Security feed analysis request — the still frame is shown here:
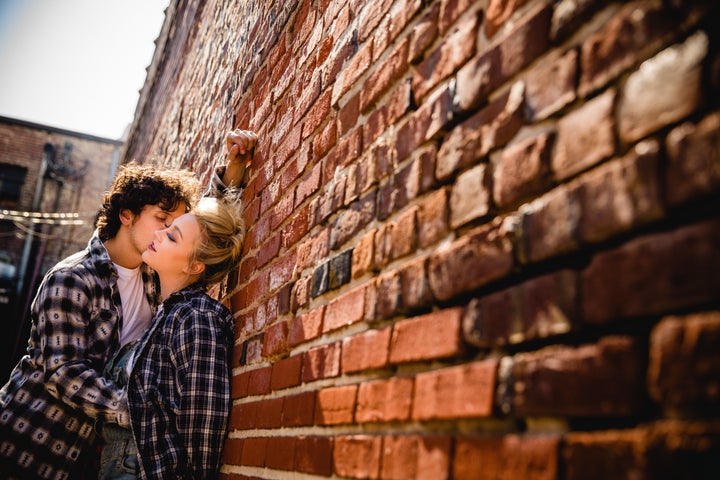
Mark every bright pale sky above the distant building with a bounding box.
[0,0,170,140]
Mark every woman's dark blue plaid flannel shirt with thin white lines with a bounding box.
[127,285,234,479]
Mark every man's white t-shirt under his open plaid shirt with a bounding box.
[114,263,152,345]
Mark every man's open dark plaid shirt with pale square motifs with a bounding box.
[0,233,159,479]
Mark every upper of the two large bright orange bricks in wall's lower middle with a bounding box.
[390,308,463,363]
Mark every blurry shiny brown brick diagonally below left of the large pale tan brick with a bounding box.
[578,141,664,243]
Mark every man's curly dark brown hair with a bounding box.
[96,161,200,242]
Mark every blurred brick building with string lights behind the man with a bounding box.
[0,116,123,383]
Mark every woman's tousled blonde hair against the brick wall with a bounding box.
[191,190,245,285]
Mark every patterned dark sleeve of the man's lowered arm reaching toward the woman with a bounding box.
[38,272,129,426]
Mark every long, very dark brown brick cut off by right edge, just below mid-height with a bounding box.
[581,220,720,324]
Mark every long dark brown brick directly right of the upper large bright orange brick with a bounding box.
[463,270,579,348]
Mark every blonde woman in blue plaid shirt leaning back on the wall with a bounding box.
[100,194,245,480]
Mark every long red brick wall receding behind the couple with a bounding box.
[126,0,720,480]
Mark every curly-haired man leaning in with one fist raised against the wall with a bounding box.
[0,130,257,480]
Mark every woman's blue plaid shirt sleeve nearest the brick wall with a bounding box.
[172,310,230,478]
